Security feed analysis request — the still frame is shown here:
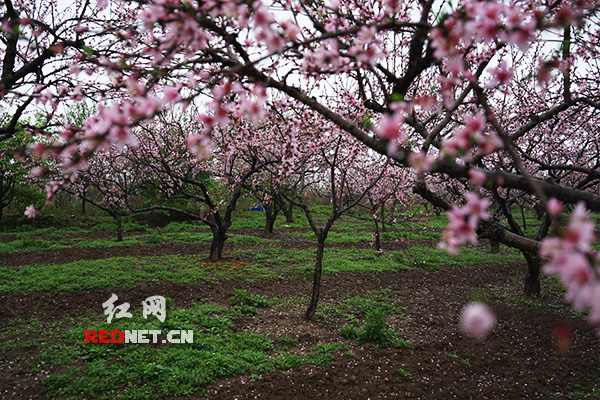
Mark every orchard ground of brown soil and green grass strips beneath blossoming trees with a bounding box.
[0,206,600,399]
